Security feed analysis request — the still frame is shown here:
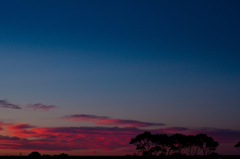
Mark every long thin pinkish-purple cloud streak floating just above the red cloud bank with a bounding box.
[61,114,164,127]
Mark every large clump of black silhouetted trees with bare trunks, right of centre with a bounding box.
[130,132,219,156]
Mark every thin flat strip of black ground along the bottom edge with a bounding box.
[0,155,240,159]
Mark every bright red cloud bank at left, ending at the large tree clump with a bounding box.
[0,124,141,151]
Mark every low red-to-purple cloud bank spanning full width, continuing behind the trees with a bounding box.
[0,122,240,155]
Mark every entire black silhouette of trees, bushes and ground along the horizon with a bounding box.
[0,137,240,159]
